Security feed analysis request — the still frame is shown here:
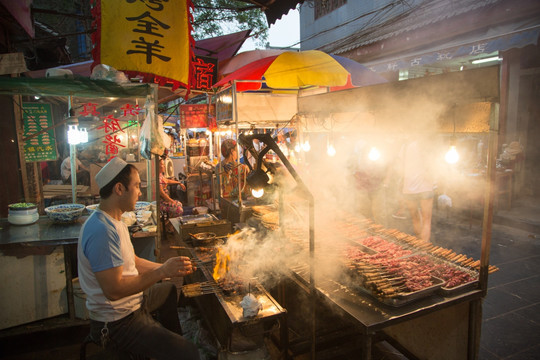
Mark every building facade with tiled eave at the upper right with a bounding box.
[300,0,540,195]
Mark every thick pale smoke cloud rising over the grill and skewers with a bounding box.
[217,88,489,294]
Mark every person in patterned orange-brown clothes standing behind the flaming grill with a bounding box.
[219,139,249,198]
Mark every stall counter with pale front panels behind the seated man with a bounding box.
[0,216,156,329]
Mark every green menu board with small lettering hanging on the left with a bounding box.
[22,103,58,162]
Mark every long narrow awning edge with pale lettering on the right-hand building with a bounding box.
[365,24,540,73]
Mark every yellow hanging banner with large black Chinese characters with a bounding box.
[92,0,193,88]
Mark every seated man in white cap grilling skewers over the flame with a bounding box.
[77,157,199,360]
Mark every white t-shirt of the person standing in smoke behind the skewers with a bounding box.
[401,141,434,194]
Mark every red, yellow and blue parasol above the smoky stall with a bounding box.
[214,50,386,91]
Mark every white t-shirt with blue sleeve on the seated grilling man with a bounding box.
[77,209,143,322]
